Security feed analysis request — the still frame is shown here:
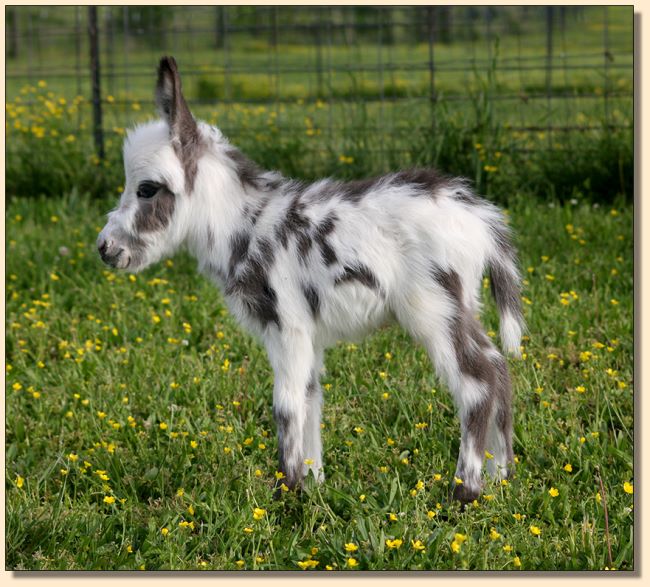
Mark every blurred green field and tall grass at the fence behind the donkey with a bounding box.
[6,7,633,203]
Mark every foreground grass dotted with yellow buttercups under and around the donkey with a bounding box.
[5,193,635,570]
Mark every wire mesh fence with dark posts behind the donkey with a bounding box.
[5,6,634,167]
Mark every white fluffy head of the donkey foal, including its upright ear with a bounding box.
[97,57,204,271]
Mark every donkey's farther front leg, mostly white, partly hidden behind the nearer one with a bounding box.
[302,350,325,483]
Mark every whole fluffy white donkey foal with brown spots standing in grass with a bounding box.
[97,57,523,502]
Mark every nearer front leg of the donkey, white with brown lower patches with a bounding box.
[267,331,314,489]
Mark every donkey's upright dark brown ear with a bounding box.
[156,57,201,185]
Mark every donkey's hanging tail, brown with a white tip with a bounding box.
[488,224,524,357]
